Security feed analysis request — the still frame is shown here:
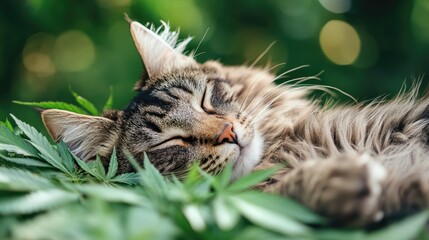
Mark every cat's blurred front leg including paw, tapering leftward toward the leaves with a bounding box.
[270,153,386,226]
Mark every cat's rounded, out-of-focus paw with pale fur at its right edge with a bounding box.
[306,154,387,226]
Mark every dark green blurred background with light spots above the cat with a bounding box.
[0,0,429,131]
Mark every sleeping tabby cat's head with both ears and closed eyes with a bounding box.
[42,22,263,177]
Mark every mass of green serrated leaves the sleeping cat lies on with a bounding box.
[0,94,429,239]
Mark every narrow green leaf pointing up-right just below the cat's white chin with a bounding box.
[226,166,280,192]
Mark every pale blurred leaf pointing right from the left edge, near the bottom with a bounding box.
[0,189,78,214]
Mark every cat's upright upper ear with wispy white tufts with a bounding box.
[130,21,196,77]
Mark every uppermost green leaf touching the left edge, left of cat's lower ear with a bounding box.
[0,126,38,157]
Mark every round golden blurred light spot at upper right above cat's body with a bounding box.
[319,20,361,65]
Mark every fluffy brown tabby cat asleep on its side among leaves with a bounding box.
[42,21,429,226]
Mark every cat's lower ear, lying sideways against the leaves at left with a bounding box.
[41,109,119,160]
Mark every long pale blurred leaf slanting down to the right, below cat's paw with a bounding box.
[228,196,311,236]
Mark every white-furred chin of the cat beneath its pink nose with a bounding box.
[232,130,264,180]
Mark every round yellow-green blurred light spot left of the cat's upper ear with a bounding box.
[54,30,95,72]
